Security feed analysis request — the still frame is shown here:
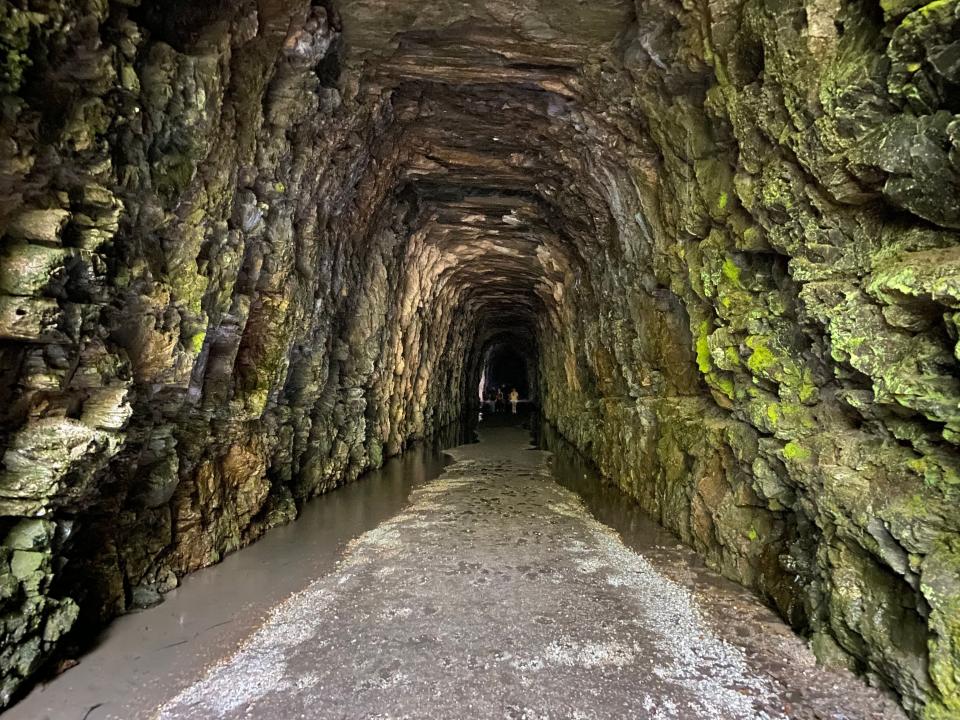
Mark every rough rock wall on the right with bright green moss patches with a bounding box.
[541,0,960,718]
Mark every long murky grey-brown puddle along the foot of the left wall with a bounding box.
[3,436,458,720]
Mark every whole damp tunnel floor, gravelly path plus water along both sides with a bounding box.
[4,416,904,720]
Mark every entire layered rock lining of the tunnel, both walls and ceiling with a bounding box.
[0,0,960,718]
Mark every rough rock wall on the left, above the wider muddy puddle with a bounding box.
[0,0,480,702]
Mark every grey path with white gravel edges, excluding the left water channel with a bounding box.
[14,427,903,720]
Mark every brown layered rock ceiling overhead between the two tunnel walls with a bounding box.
[340,6,633,338]
